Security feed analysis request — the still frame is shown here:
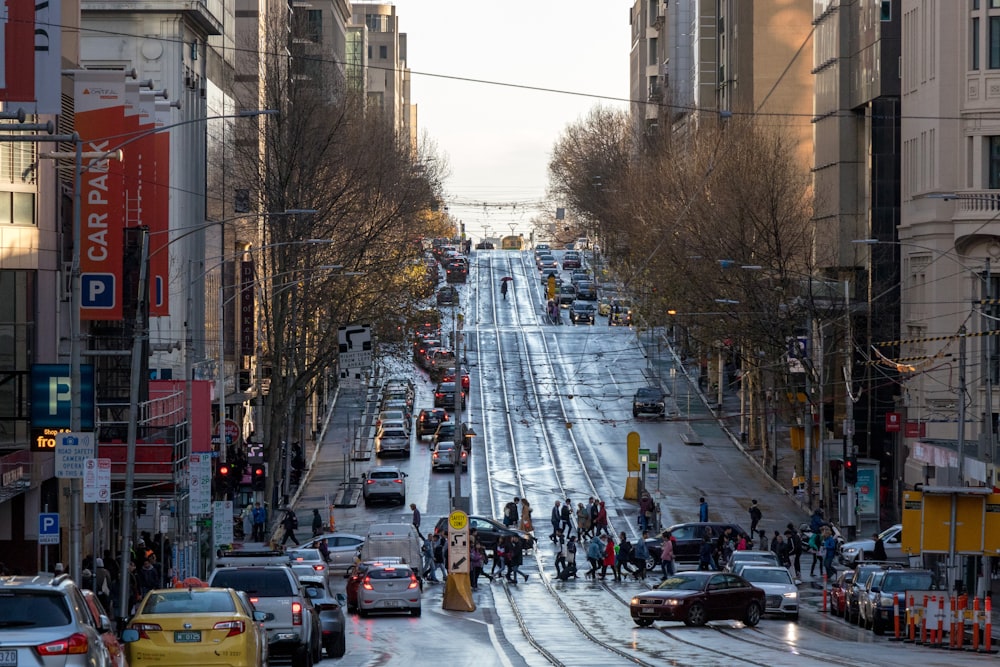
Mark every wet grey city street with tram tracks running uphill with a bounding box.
[296,250,996,667]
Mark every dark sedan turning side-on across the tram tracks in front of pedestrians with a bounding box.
[629,571,764,627]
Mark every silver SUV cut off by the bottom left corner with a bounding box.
[0,574,113,667]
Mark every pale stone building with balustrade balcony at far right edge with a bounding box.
[900,0,1000,486]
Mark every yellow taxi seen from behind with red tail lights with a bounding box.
[122,588,272,667]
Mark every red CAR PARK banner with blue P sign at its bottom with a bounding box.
[74,70,125,321]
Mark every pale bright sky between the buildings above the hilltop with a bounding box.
[393,0,632,239]
